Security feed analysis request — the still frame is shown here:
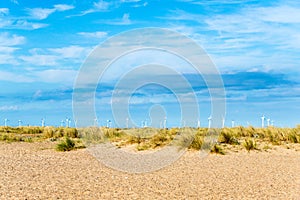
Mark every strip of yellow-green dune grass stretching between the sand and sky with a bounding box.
[0,126,300,154]
